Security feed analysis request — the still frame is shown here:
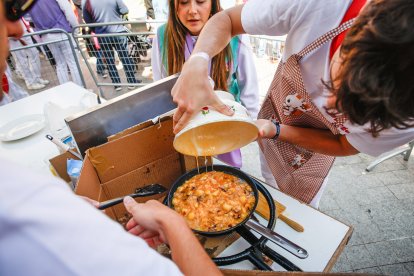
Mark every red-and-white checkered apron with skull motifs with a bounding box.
[258,19,354,203]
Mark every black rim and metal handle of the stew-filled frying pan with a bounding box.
[167,165,308,259]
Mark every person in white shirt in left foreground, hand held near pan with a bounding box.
[0,0,220,275]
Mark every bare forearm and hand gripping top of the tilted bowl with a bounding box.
[171,6,244,133]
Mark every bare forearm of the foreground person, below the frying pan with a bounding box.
[162,217,221,276]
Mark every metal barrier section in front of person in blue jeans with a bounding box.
[72,20,162,98]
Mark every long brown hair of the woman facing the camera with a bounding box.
[161,0,232,91]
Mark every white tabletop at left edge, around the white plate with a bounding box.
[0,82,98,176]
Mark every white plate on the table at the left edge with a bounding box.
[0,114,45,141]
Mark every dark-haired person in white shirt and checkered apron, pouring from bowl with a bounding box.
[168,0,414,206]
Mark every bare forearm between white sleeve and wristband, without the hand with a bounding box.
[193,6,244,57]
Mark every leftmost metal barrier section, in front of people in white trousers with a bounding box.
[9,29,86,93]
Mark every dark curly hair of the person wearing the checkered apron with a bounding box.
[325,0,414,137]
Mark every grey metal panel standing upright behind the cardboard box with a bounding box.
[65,74,178,156]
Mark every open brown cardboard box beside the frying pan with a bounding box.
[76,117,209,223]
